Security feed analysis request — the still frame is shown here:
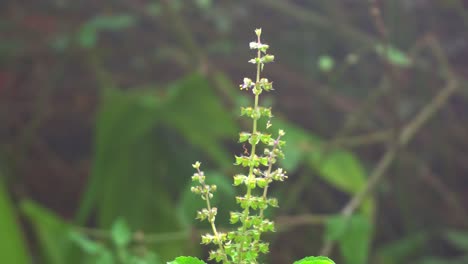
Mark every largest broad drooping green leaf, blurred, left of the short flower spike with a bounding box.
[78,89,186,259]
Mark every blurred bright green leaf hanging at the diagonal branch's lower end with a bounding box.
[325,214,372,264]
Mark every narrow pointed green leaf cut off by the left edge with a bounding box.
[0,178,31,264]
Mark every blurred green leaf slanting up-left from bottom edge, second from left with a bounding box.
[20,200,80,264]
